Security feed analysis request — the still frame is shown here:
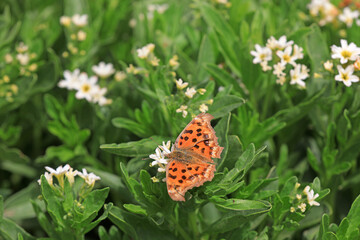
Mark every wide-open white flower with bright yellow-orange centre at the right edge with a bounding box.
[331,39,360,64]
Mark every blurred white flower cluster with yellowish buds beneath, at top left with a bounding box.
[60,14,88,57]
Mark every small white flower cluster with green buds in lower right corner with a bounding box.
[290,183,320,213]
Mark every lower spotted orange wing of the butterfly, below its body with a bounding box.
[166,160,215,201]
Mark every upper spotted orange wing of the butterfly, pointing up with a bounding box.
[174,113,223,159]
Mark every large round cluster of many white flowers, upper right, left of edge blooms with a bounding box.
[250,36,309,88]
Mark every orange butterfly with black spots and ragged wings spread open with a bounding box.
[165,113,223,201]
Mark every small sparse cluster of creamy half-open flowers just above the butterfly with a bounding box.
[175,78,213,118]
